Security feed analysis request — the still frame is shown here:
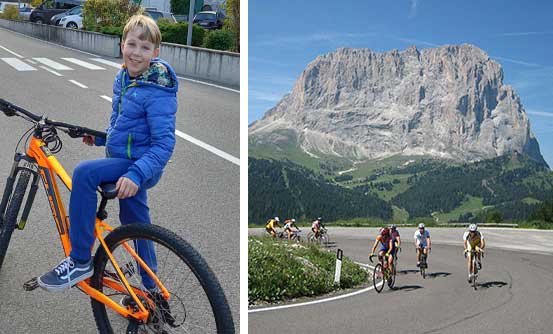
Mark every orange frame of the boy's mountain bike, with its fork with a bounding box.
[4,134,170,322]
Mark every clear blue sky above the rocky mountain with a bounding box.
[248,0,553,167]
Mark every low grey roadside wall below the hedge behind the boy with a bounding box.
[0,19,240,87]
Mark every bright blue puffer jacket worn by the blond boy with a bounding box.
[95,58,178,187]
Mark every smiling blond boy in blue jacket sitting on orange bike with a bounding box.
[38,15,178,291]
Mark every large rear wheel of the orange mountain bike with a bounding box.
[91,224,235,334]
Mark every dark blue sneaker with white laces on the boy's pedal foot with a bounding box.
[37,257,94,292]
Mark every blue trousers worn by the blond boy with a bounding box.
[69,158,160,289]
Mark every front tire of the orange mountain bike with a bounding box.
[0,170,31,268]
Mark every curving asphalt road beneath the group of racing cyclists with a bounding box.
[248,229,553,334]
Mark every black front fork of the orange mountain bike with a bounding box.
[0,153,40,230]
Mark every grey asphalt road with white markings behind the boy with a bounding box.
[0,29,240,334]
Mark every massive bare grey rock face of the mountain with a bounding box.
[249,45,545,164]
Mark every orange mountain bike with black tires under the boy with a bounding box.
[0,99,235,334]
